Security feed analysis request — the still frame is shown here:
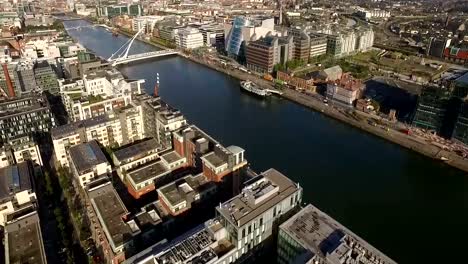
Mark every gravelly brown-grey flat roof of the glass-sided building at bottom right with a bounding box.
[280,204,396,264]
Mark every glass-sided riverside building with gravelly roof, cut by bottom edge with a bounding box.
[278,204,396,264]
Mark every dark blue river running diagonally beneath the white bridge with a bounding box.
[65,21,468,264]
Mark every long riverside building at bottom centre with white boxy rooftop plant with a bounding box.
[126,169,302,264]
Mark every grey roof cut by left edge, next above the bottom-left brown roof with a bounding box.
[0,161,33,201]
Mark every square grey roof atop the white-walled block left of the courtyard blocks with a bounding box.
[69,140,107,174]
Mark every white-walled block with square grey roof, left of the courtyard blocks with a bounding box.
[69,140,112,188]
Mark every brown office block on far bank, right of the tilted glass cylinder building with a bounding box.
[246,35,294,73]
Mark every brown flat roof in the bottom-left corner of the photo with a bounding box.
[5,211,47,264]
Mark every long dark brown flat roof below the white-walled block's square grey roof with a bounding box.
[88,182,133,247]
